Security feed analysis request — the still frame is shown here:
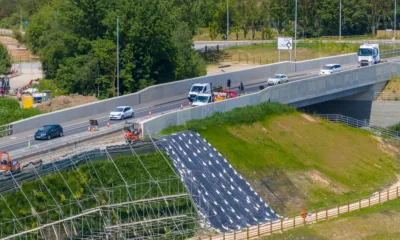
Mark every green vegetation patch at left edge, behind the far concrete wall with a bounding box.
[0,98,42,126]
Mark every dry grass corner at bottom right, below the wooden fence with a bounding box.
[262,199,400,240]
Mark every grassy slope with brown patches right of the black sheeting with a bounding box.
[161,103,399,216]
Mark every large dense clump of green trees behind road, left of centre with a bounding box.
[22,0,206,97]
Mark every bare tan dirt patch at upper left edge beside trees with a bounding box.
[0,36,39,62]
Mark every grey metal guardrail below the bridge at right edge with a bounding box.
[313,114,400,141]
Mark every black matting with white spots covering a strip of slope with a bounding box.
[160,131,280,232]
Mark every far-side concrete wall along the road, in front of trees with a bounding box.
[12,54,357,134]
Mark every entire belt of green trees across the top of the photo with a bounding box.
[0,0,394,97]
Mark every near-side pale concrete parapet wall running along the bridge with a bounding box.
[141,63,400,135]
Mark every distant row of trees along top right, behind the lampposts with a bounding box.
[201,0,400,39]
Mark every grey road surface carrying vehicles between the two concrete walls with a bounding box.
[0,58,399,156]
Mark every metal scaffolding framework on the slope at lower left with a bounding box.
[0,139,200,240]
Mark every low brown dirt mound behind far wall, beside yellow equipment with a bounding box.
[36,94,98,112]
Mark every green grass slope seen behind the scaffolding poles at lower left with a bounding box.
[0,153,191,236]
